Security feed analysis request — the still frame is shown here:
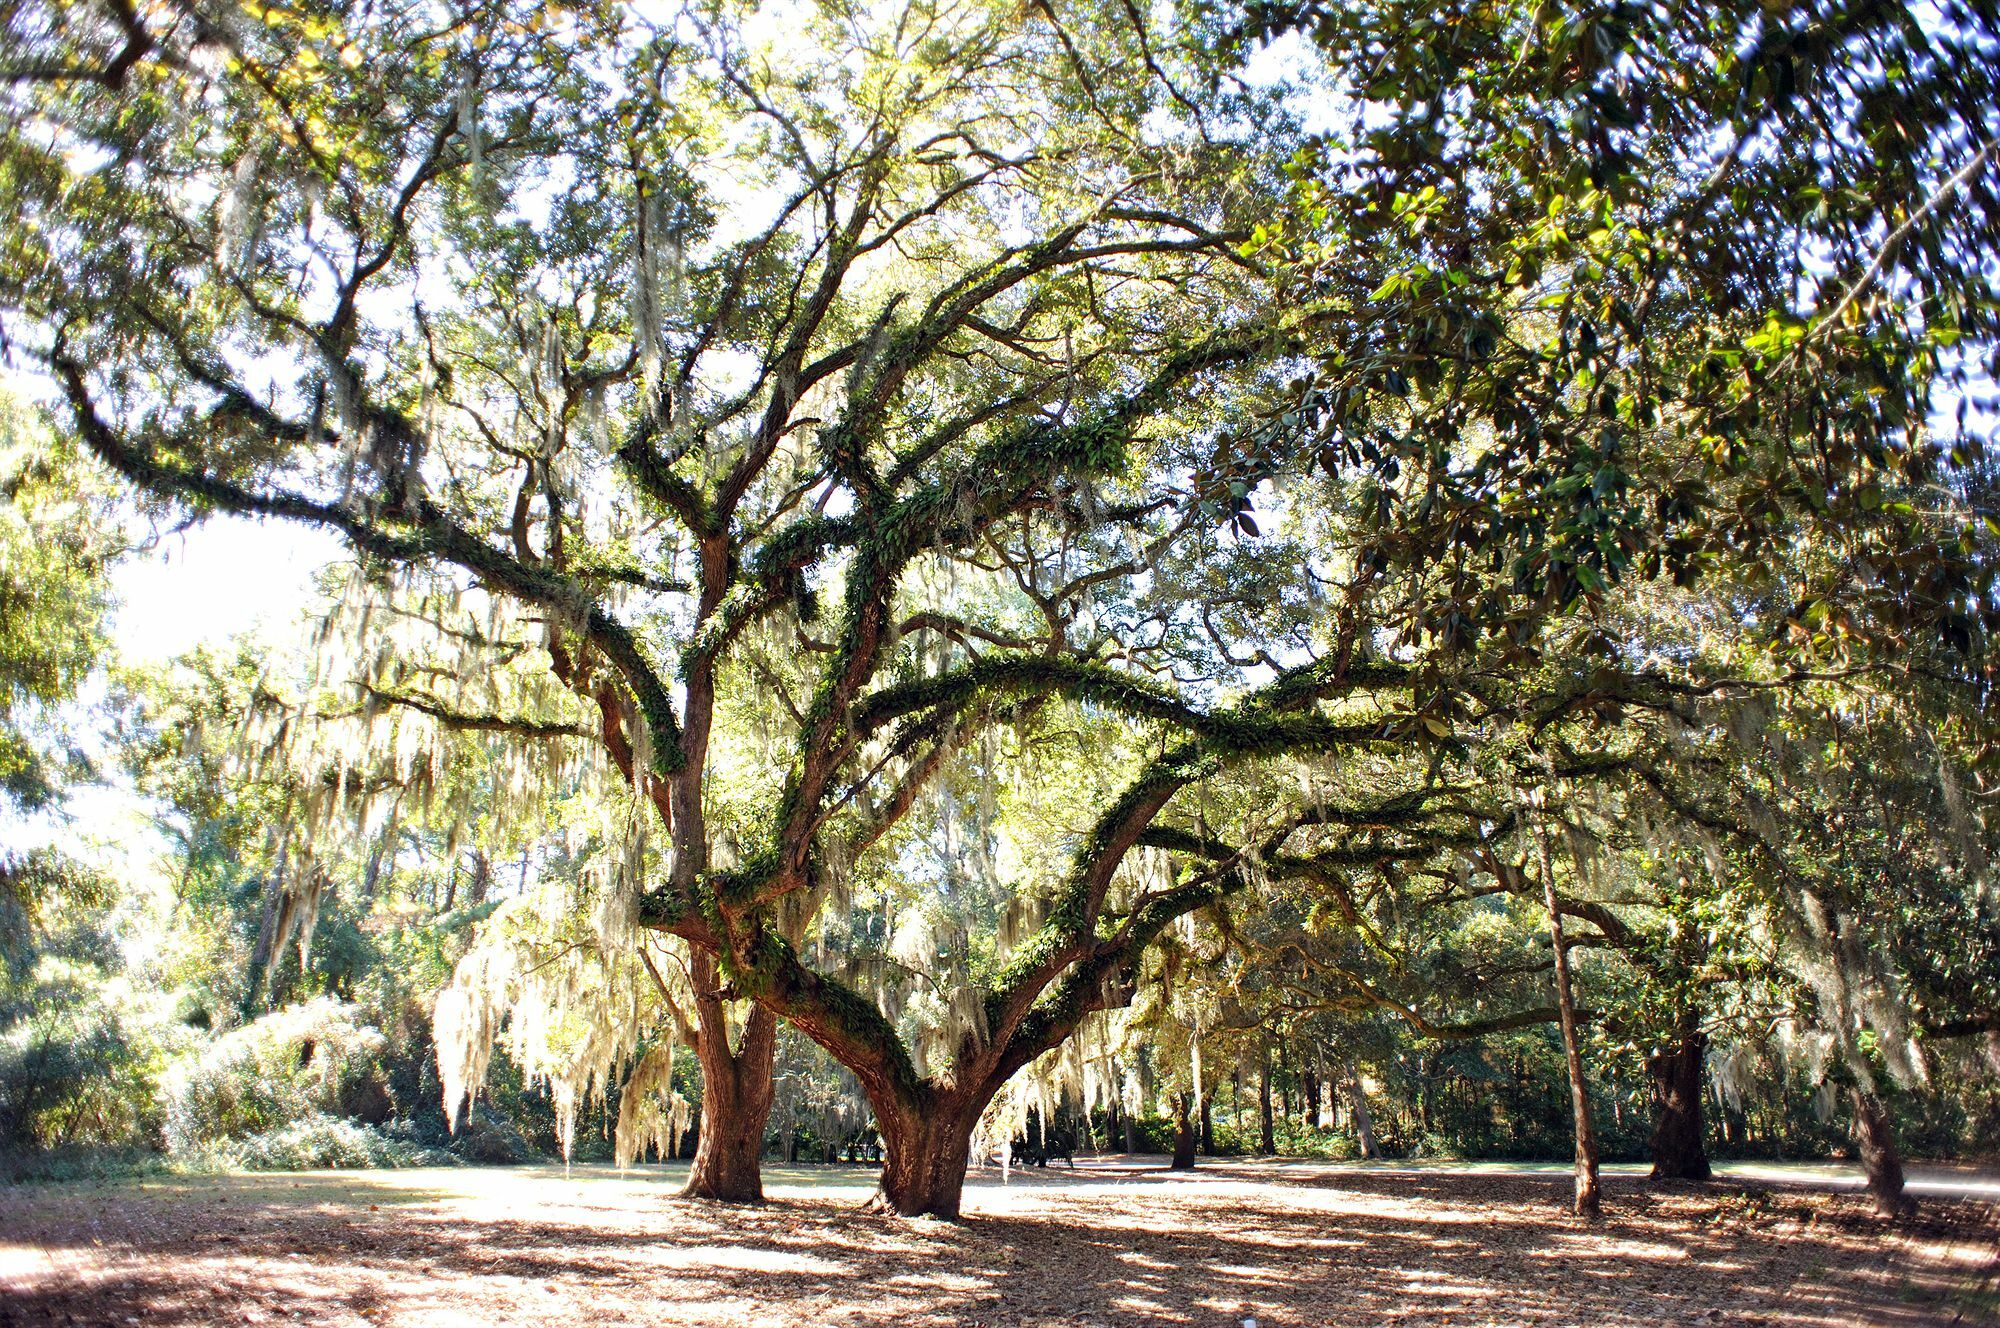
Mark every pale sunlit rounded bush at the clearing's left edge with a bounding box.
[164,996,386,1156]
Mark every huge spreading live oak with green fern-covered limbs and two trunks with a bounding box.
[4,6,1362,1214]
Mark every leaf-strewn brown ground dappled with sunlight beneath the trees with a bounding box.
[0,1164,2000,1328]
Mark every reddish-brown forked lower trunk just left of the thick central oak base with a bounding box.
[680,956,778,1204]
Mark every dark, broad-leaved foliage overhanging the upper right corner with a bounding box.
[1214,0,2000,676]
